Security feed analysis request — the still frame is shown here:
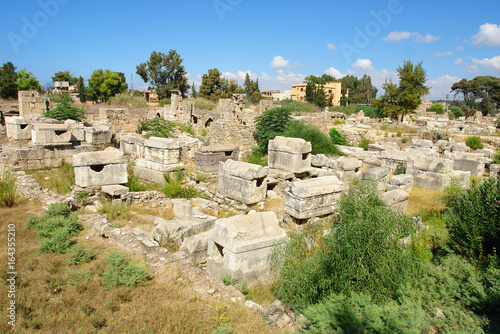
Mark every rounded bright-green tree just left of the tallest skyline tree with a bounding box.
[87,69,127,102]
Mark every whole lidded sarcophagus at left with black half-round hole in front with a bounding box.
[73,148,128,187]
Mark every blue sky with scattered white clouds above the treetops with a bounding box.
[0,0,500,98]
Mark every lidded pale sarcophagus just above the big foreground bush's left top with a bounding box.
[285,175,344,219]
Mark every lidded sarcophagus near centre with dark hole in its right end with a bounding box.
[219,160,267,204]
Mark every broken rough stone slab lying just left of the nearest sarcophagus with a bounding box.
[153,215,217,244]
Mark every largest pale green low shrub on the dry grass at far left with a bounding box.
[27,203,83,254]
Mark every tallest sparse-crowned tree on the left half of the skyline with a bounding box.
[136,50,190,100]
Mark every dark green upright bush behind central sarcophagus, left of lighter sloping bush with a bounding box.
[253,108,292,154]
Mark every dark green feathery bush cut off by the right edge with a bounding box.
[445,177,500,262]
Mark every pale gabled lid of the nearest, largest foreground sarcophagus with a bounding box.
[212,212,287,253]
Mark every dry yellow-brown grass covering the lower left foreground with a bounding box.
[0,199,269,333]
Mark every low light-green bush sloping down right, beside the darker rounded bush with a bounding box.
[283,121,344,156]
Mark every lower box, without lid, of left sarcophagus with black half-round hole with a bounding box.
[75,164,128,187]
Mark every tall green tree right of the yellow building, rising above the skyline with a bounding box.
[398,60,429,121]
